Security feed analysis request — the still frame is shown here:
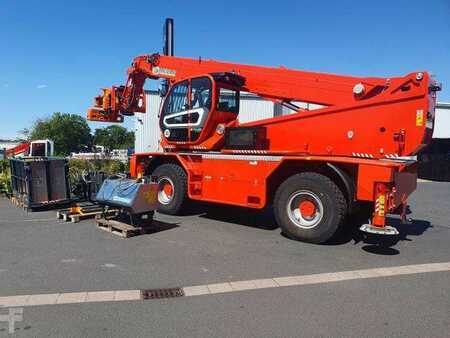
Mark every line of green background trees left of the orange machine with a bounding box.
[20,112,134,156]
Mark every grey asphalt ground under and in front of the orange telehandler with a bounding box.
[0,183,450,337]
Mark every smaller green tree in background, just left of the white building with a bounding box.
[94,126,134,150]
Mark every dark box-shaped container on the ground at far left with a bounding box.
[10,157,70,209]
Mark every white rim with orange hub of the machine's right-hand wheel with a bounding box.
[286,190,323,229]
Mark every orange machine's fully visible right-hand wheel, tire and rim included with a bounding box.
[274,172,347,243]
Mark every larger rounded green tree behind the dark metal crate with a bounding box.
[29,113,92,156]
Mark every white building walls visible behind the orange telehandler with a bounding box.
[135,91,450,153]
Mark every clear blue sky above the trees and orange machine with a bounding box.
[0,0,450,139]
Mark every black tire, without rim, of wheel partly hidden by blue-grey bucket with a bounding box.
[152,163,187,215]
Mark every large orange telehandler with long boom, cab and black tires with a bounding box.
[88,19,441,243]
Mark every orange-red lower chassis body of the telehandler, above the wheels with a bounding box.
[131,153,417,208]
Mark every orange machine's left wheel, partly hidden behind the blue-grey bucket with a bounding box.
[152,163,187,215]
